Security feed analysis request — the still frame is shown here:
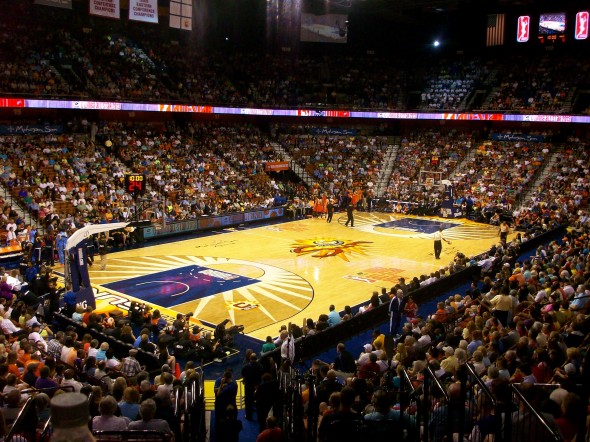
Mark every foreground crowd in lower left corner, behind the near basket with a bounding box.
[0,268,215,437]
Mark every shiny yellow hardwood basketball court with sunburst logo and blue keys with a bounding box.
[85,212,506,340]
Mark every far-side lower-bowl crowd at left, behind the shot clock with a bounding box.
[0,120,294,231]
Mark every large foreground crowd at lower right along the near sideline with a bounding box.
[263,208,590,441]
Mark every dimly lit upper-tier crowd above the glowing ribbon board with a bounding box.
[0,7,587,112]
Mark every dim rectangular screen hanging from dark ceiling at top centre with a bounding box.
[300,13,348,43]
